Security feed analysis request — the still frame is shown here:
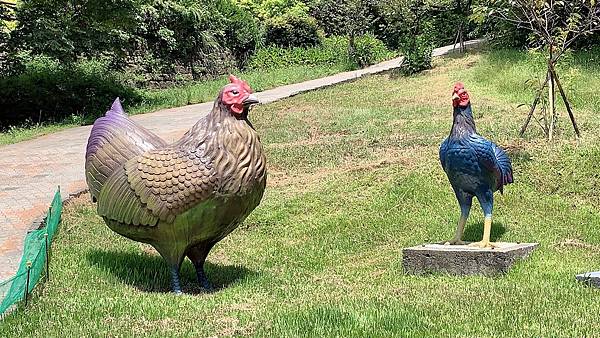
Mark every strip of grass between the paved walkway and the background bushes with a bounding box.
[0,64,347,146]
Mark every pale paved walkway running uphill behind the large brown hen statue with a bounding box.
[0,41,480,281]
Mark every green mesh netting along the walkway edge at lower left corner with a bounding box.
[0,189,62,315]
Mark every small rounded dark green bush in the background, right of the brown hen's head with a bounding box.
[265,13,322,47]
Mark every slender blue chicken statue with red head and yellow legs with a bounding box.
[440,83,513,248]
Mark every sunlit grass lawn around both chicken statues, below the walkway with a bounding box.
[0,51,600,337]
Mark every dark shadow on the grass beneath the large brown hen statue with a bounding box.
[86,249,257,294]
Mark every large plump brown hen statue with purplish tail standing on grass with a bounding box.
[85,75,267,294]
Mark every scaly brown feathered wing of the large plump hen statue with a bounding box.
[98,148,218,226]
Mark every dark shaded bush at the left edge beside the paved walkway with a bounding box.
[0,56,142,129]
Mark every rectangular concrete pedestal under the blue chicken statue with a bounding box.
[402,242,538,276]
